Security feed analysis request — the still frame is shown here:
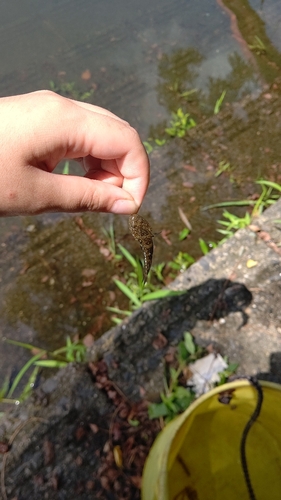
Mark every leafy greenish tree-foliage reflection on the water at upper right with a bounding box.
[150,48,259,136]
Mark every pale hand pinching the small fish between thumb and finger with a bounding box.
[0,91,149,216]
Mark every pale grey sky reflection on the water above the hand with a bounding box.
[0,0,252,135]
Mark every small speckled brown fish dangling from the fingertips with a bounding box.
[129,214,154,283]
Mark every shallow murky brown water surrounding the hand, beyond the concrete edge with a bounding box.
[0,0,281,398]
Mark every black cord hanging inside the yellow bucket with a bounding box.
[240,377,263,500]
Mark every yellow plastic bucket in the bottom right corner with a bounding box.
[142,379,281,500]
